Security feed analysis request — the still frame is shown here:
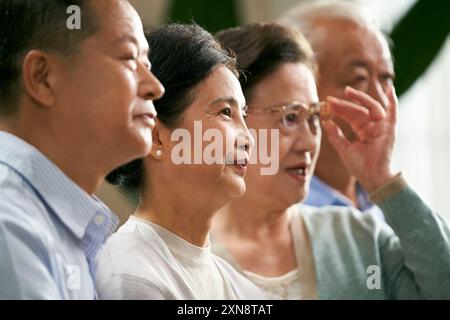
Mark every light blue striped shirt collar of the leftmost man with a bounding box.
[0,131,118,239]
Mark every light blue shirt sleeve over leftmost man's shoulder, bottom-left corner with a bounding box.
[0,170,60,299]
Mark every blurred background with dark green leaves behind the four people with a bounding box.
[97,0,450,223]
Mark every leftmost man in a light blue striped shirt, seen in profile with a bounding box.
[0,0,164,299]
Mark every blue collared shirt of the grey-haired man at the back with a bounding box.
[304,176,384,221]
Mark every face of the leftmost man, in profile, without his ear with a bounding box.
[54,0,164,170]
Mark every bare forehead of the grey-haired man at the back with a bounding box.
[314,18,392,69]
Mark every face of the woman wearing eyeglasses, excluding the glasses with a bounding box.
[242,63,321,210]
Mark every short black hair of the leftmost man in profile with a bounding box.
[0,0,97,116]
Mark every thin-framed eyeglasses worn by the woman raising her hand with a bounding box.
[247,101,328,134]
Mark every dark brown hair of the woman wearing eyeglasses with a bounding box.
[216,22,317,101]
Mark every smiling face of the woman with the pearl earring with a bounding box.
[150,66,253,206]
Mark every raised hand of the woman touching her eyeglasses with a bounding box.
[322,86,398,193]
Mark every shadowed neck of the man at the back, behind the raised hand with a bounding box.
[315,136,358,206]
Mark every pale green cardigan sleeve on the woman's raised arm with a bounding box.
[371,175,450,299]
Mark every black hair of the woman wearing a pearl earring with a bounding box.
[106,24,238,195]
